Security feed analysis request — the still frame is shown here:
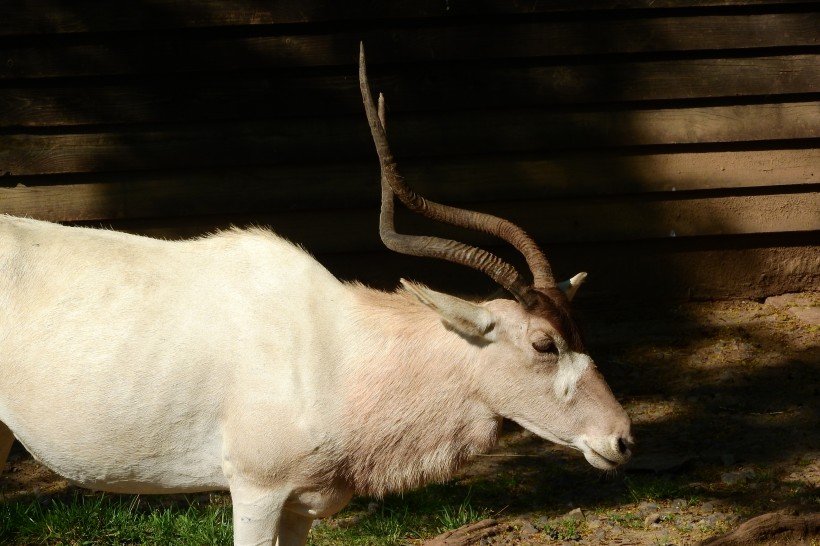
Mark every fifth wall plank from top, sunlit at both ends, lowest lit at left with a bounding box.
[0,148,820,221]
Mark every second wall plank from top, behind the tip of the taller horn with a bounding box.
[0,11,820,79]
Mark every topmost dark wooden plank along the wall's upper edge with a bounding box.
[0,0,811,36]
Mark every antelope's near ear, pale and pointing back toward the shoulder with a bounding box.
[401,279,495,341]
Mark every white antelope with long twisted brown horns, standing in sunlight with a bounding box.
[0,46,632,546]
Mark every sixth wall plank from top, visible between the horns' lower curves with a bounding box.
[57,189,820,248]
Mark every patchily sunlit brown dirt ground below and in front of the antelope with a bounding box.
[0,293,820,546]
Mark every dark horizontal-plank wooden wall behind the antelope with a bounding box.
[0,0,820,298]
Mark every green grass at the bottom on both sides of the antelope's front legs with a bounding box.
[0,484,489,546]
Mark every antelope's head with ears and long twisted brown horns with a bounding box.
[359,46,633,470]
